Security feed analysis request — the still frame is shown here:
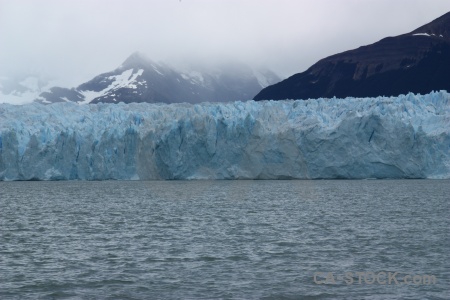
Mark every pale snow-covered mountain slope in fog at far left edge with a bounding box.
[0,74,51,104]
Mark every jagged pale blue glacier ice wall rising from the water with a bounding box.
[0,91,450,180]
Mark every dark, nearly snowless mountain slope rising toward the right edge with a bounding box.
[254,12,450,100]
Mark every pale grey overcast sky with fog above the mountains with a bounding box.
[0,0,450,87]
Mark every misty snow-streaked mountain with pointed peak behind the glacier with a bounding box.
[36,52,280,104]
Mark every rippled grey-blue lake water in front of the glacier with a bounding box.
[0,180,450,299]
